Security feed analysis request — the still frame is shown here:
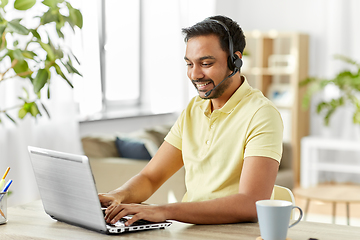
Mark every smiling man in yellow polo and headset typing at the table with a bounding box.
[99,16,283,225]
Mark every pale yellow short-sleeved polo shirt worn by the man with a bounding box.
[165,79,283,202]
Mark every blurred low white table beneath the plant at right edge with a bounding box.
[300,136,360,188]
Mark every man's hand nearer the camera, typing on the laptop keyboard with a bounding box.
[105,203,166,226]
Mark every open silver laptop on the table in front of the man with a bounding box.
[28,146,171,234]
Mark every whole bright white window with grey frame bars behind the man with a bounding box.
[74,0,193,121]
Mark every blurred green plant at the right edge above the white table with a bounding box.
[300,55,360,126]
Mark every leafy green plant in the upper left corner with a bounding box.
[0,0,83,123]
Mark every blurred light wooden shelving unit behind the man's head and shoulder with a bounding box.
[242,31,309,186]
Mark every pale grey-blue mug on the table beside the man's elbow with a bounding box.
[256,200,303,240]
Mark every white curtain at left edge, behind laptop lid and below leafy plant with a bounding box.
[0,1,82,206]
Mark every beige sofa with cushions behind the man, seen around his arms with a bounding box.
[81,125,293,204]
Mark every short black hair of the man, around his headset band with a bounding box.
[182,15,246,54]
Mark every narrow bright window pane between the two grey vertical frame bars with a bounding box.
[100,0,141,109]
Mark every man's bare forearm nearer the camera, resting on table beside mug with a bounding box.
[161,194,257,224]
